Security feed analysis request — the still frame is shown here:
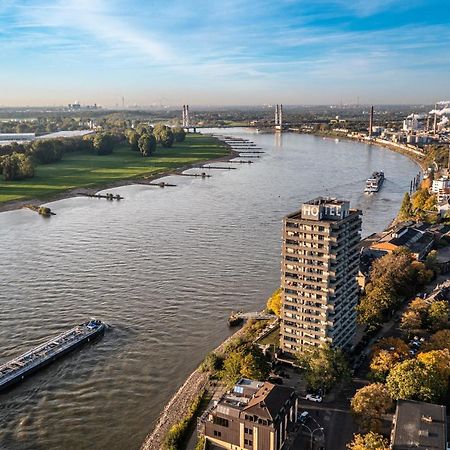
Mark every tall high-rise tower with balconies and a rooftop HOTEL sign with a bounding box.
[281,197,362,355]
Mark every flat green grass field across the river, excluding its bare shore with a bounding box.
[0,135,228,204]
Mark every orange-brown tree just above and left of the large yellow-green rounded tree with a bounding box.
[370,337,409,381]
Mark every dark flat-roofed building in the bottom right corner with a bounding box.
[391,400,447,450]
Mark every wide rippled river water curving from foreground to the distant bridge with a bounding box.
[0,129,418,450]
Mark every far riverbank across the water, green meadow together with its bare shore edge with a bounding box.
[0,134,234,212]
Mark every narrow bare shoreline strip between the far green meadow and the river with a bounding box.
[0,142,239,213]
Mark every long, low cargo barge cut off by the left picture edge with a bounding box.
[0,319,106,391]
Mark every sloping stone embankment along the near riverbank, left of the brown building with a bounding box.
[141,328,251,450]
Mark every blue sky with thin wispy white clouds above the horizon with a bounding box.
[0,0,450,106]
